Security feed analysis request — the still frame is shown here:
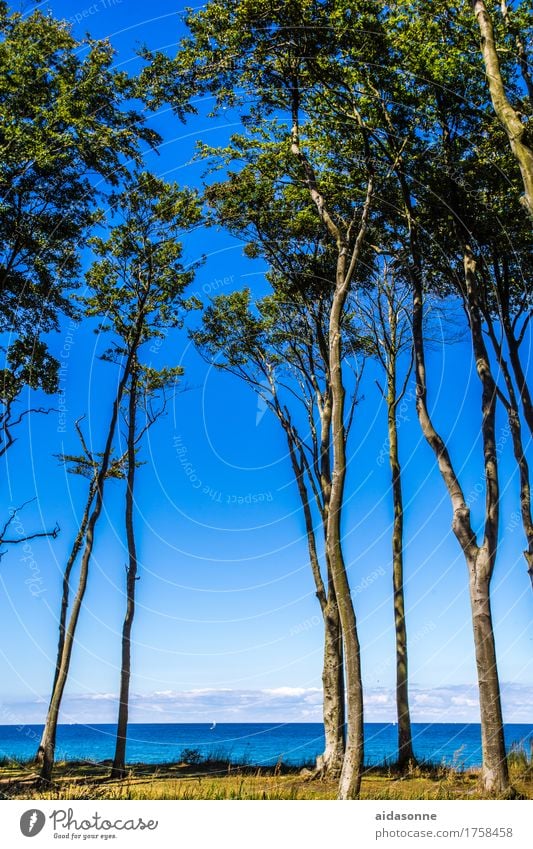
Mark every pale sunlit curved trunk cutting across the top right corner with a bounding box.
[472,0,533,219]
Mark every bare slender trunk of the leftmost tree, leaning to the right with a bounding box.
[39,326,140,784]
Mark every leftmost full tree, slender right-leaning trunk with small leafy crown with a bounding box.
[36,173,199,782]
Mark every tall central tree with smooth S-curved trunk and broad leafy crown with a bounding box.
[143,0,385,798]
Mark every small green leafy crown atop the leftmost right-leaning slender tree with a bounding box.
[84,171,201,419]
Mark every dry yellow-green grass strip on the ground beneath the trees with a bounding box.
[0,748,533,801]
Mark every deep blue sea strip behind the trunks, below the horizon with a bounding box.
[0,723,533,769]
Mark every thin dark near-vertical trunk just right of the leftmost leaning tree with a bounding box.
[111,366,138,778]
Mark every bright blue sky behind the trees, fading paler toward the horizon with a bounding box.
[0,0,533,724]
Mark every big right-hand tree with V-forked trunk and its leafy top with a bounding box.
[374,4,511,794]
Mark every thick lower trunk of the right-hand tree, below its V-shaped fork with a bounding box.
[469,548,509,795]
